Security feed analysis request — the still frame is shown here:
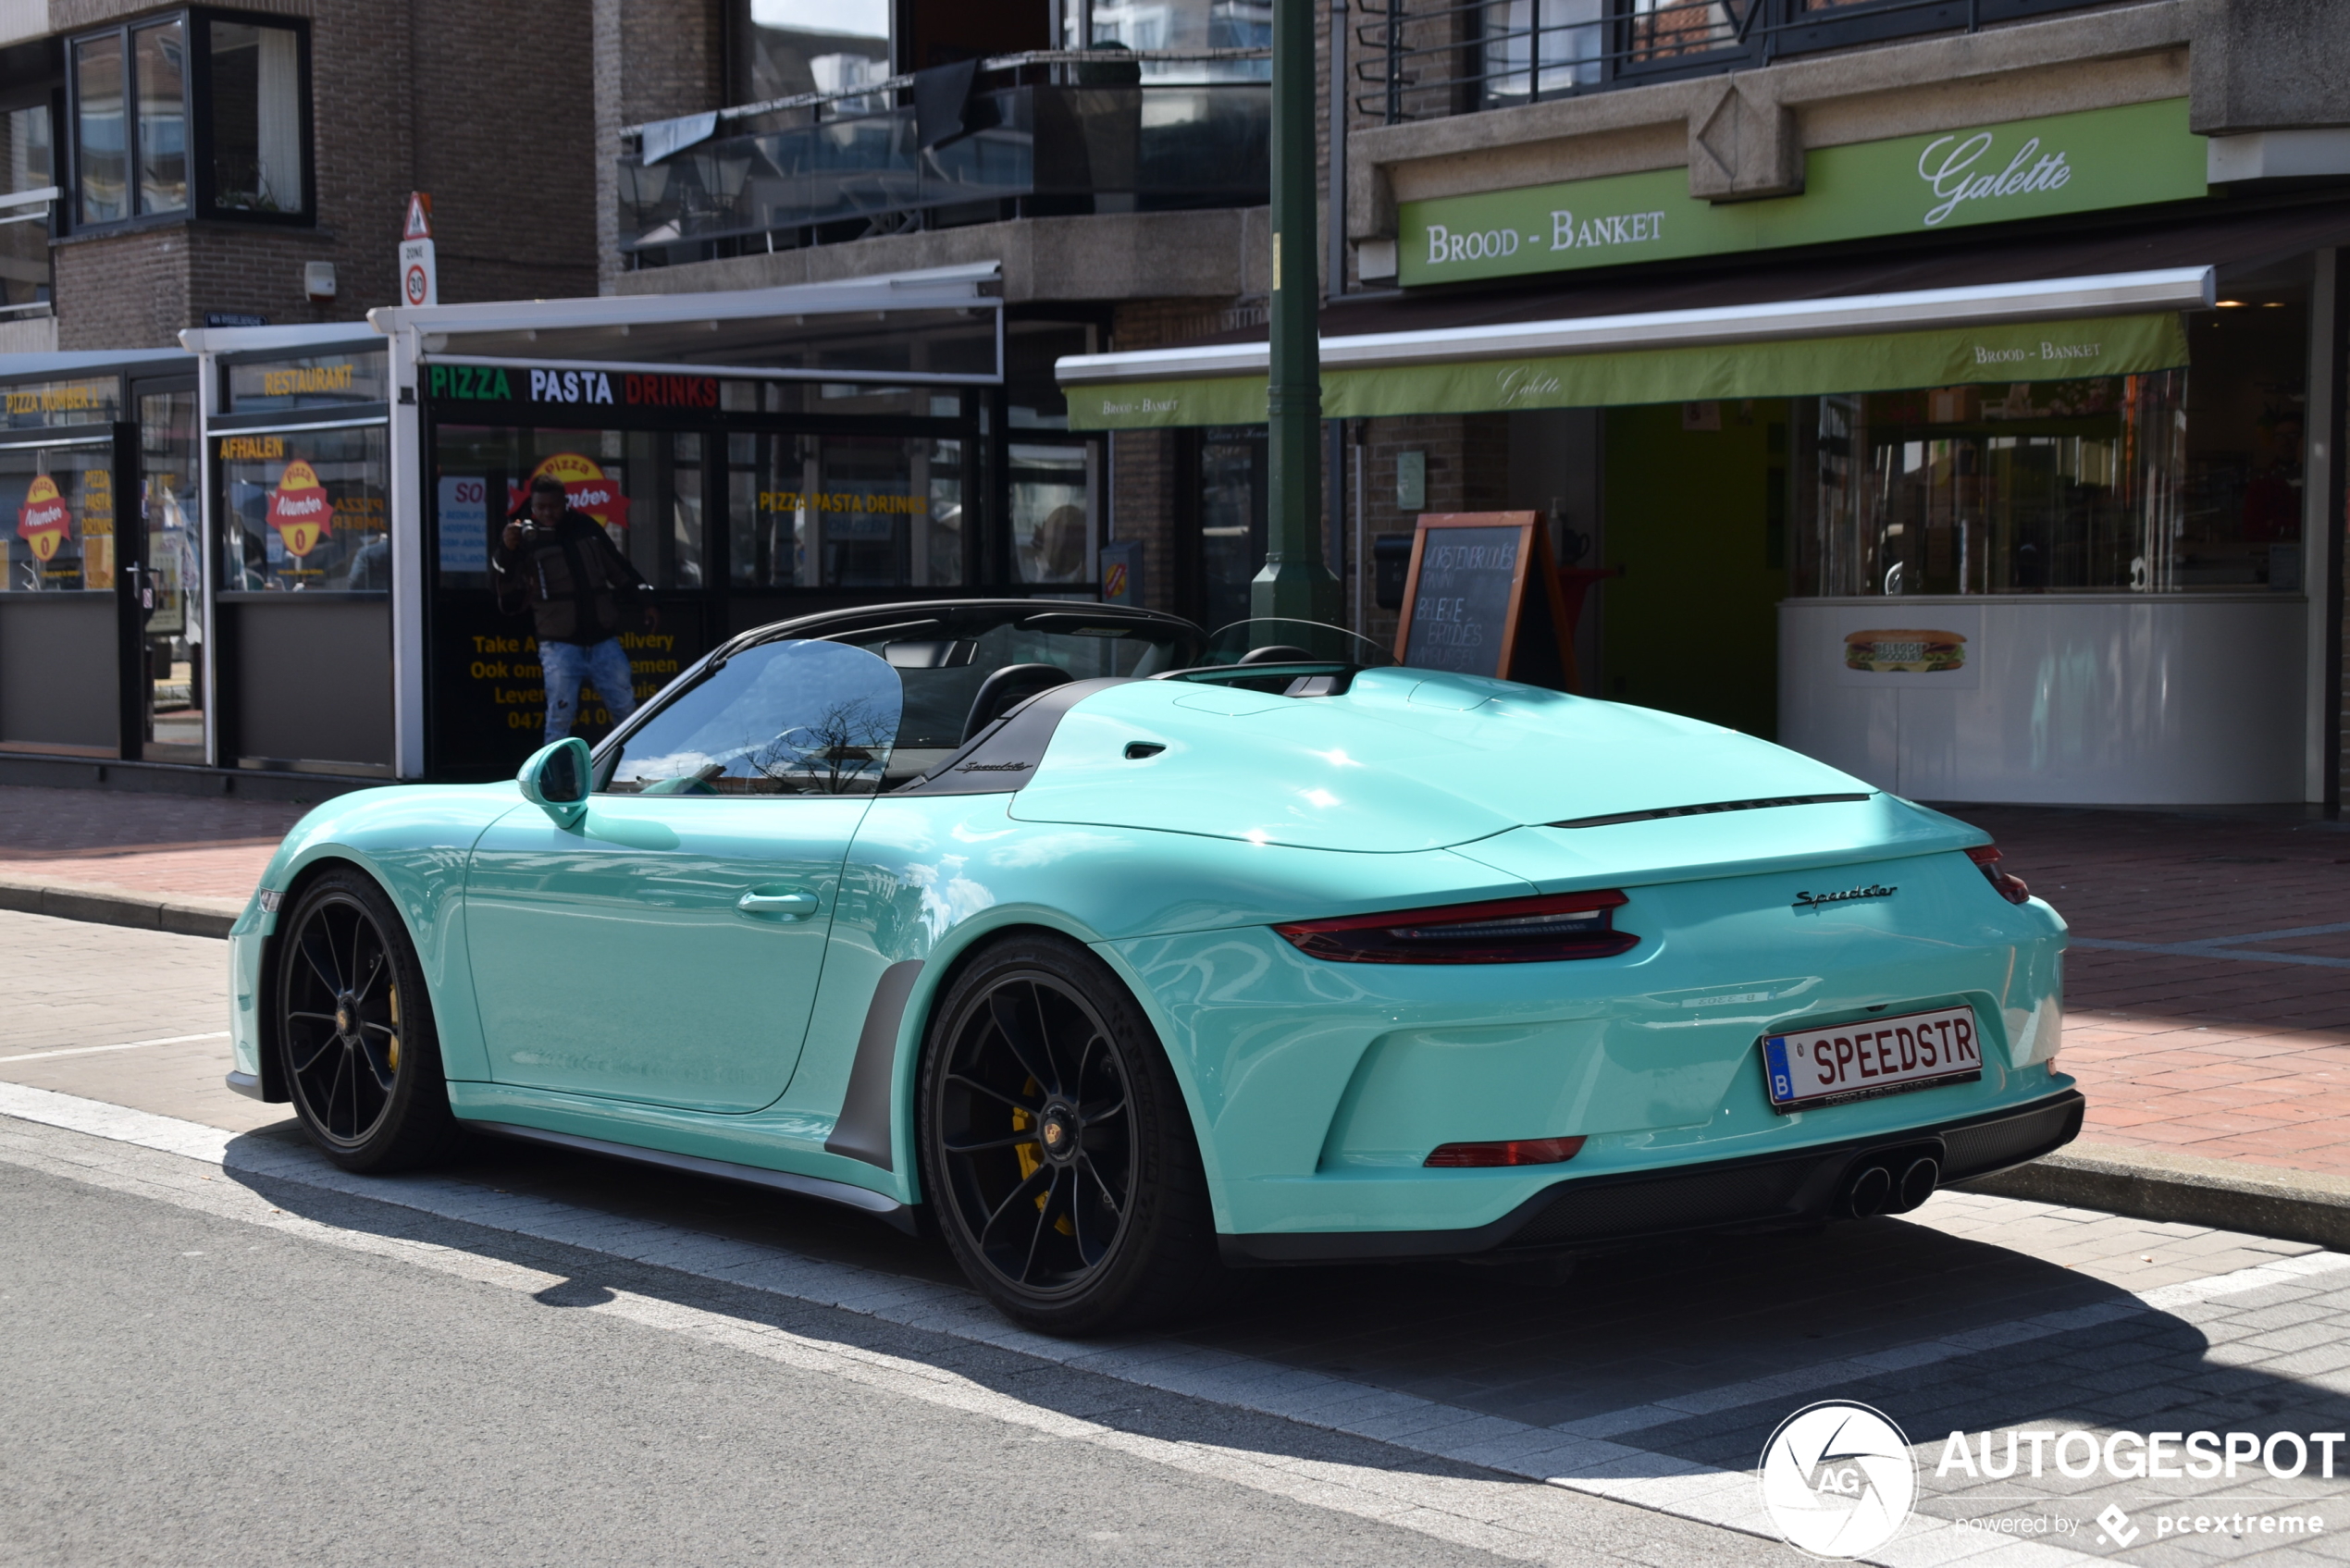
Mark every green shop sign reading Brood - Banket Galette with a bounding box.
[1396,99,2209,287]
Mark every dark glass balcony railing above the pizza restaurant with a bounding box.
[618,49,1271,268]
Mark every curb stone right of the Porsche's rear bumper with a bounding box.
[1953,1142,2350,1253]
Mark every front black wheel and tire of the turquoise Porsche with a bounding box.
[273,870,458,1173]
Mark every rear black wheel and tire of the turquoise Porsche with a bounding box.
[917,931,1219,1335]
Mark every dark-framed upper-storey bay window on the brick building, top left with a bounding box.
[66,12,310,228]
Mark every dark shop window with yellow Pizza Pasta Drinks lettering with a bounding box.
[726,435,966,587]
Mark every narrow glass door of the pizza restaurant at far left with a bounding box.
[130,388,207,761]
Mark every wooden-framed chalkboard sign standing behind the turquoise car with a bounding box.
[1396,512,1577,691]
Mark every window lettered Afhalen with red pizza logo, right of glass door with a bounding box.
[216,426,392,592]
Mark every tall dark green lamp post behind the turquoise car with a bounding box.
[1248,0,1342,623]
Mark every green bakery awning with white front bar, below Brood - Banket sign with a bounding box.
[1055,265,2216,430]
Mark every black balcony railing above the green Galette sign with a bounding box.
[1356,0,2106,125]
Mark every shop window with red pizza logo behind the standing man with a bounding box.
[432,426,705,592]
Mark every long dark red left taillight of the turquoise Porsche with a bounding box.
[1274,889,1640,964]
